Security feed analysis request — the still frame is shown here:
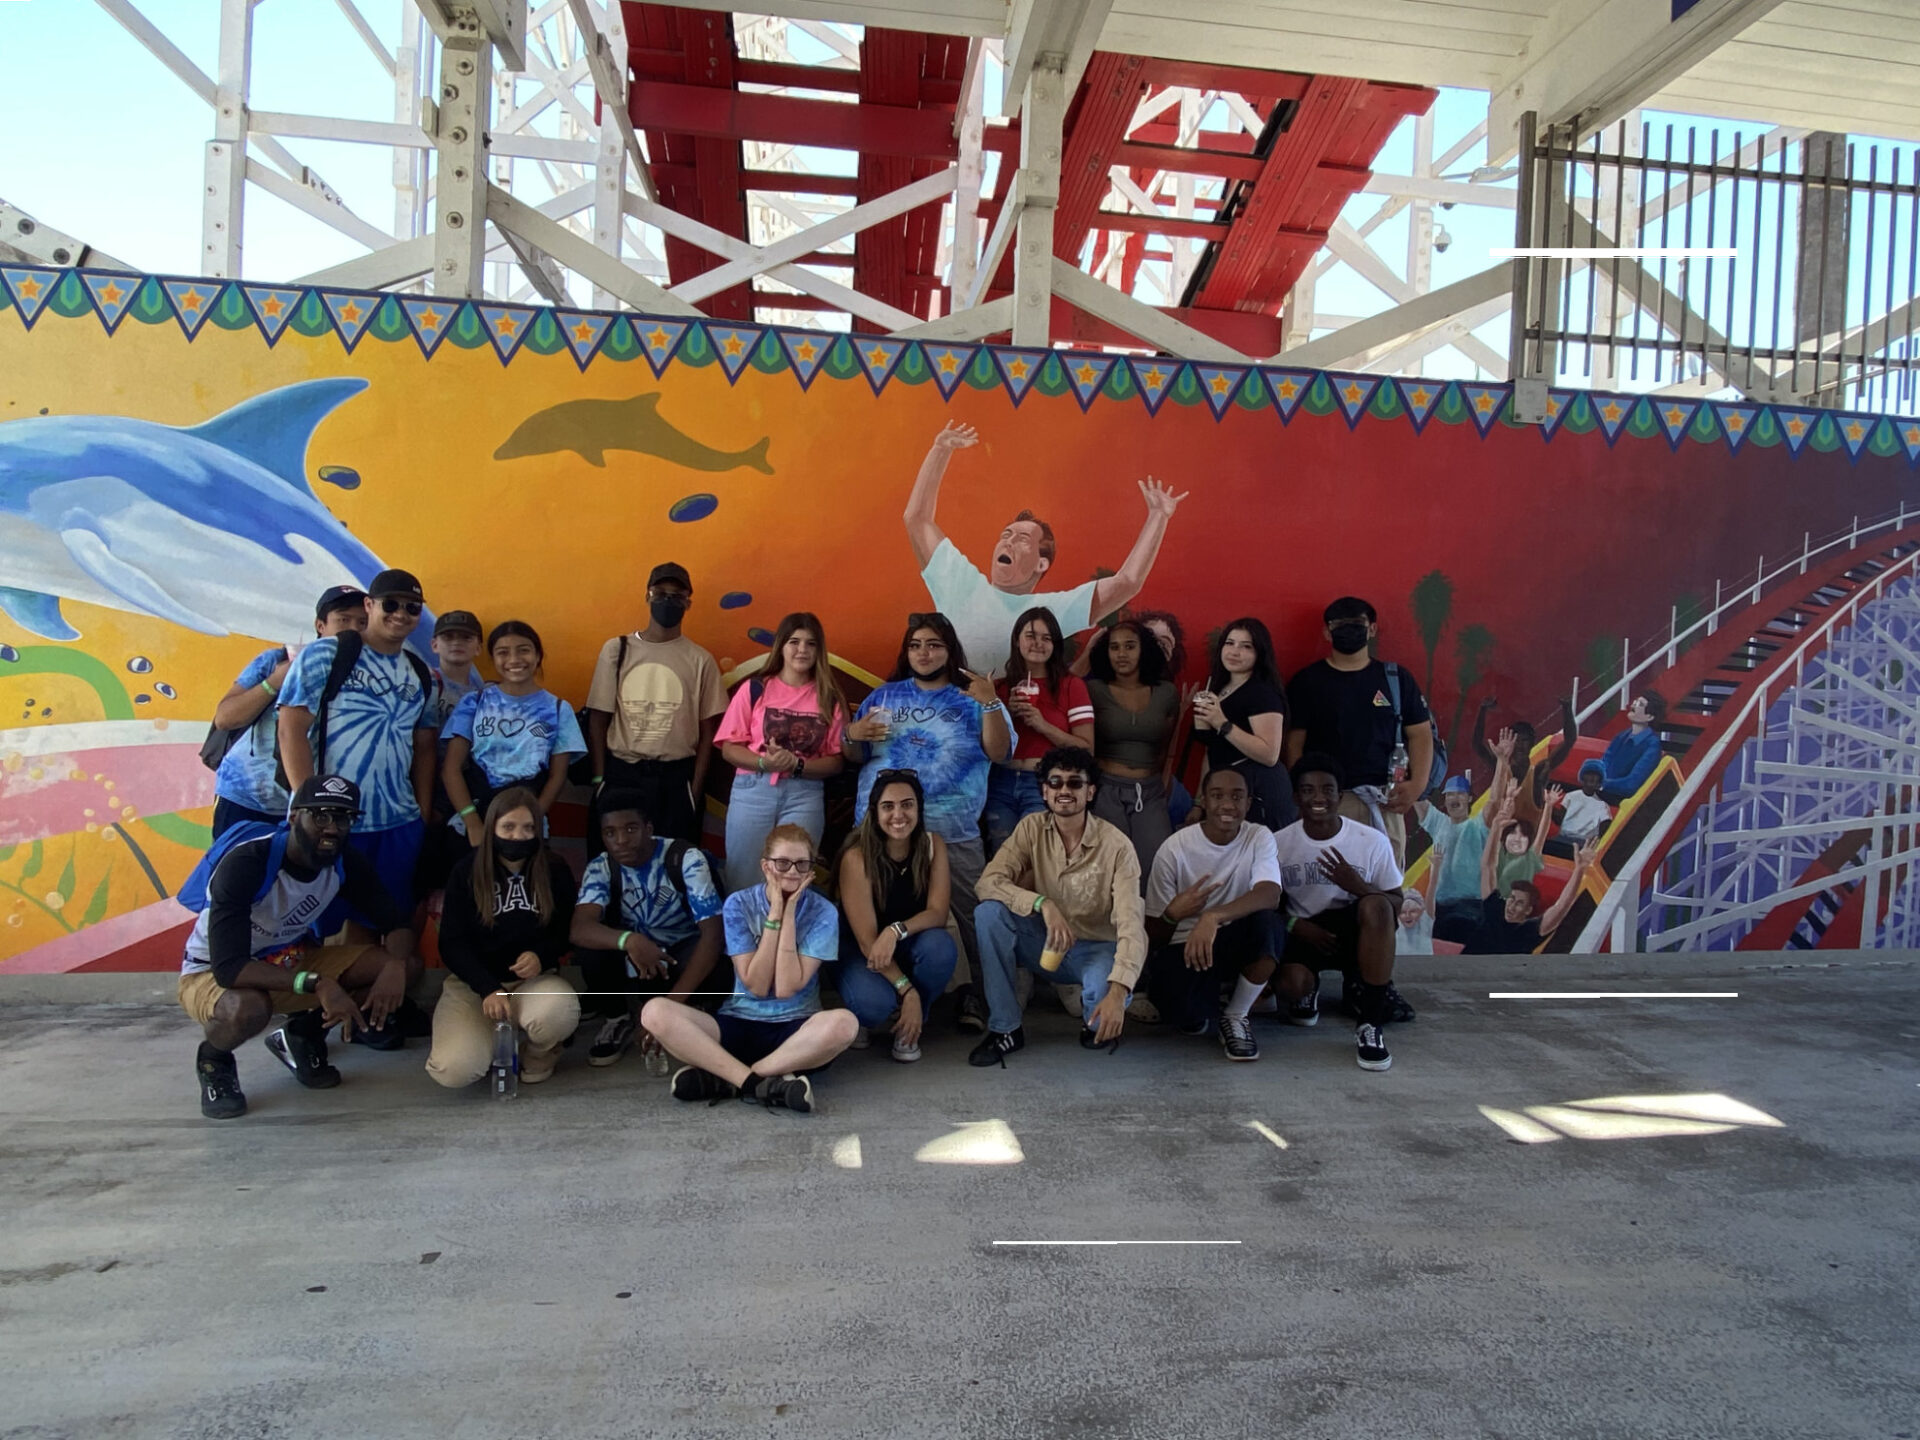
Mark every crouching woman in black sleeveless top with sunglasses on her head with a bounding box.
[833,770,960,1064]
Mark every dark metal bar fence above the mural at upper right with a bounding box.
[1509,113,1920,415]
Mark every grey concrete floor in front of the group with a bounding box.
[0,956,1920,1440]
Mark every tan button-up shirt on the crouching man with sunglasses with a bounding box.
[975,810,1146,991]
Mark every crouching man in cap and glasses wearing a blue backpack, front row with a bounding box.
[180,776,420,1119]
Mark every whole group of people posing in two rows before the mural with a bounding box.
[180,564,1666,1117]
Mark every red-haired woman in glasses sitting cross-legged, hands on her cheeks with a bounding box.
[639,826,860,1112]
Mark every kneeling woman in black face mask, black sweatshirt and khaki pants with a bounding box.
[426,785,580,1089]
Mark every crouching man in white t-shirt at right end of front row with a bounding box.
[1273,751,1404,1069]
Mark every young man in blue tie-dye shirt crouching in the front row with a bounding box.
[568,787,722,1066]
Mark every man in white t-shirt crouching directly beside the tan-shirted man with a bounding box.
[1146,768,1283,1060]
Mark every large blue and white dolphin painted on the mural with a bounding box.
[0,378,432,649]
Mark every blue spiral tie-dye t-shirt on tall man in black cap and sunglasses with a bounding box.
[280,636,432,833]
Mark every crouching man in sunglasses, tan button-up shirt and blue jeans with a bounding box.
[968,745,1146,1066]
